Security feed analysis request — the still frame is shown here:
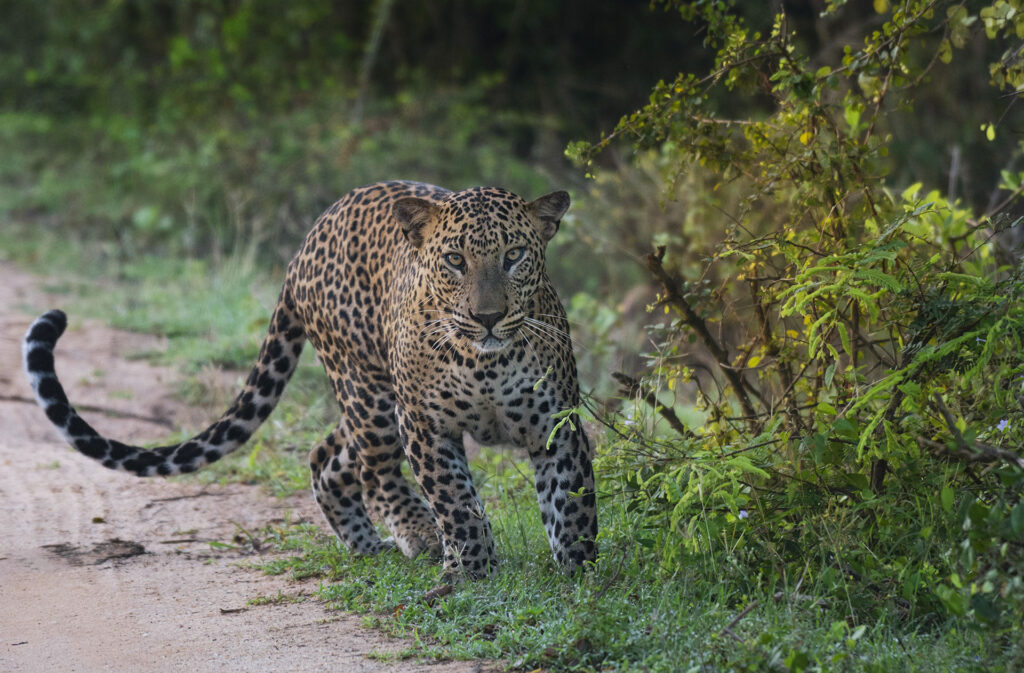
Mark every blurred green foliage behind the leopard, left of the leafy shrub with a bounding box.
[0,0,682,264]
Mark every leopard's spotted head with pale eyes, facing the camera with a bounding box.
[393,183,569,352]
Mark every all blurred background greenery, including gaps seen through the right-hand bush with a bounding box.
[0,0,1020,262]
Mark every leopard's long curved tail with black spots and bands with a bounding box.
[22,291,305,476]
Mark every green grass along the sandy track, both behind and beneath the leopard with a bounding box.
[0,220,1022,672]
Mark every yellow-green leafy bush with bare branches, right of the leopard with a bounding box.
[568,0,1024,635]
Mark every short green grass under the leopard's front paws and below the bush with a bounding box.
[247,452,1011,672]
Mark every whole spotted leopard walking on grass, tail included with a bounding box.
[23,180,597,582]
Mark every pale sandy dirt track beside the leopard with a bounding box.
[0,262,502,673]
